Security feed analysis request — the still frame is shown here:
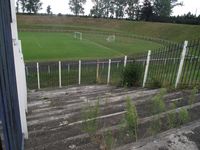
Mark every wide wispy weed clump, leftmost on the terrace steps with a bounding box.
[82,100,99,135]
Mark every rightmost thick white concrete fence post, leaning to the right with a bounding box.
[175,41,188,88]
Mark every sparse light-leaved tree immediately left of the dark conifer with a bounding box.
[126,0,139,20]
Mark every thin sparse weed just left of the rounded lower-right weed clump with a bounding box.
[167,103,177,128]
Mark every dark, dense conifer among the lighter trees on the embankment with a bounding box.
[141,0,153,21]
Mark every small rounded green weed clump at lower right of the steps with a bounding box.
[178,108,190,125]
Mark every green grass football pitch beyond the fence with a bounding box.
[19,32,163,62]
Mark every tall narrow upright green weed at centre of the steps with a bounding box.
[125,98,138,140]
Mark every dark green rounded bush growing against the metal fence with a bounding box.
[122,63,142,87]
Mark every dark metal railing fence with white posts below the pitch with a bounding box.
[26,40,200,89]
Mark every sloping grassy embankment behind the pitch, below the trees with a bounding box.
[17,15,200,42]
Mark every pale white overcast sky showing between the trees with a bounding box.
[19,0,200,15]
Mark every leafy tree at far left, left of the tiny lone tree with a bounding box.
[26,0,42,14]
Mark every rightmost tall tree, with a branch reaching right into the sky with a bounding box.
[154,0,183,17]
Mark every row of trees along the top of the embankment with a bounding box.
[16,0,200,24]
